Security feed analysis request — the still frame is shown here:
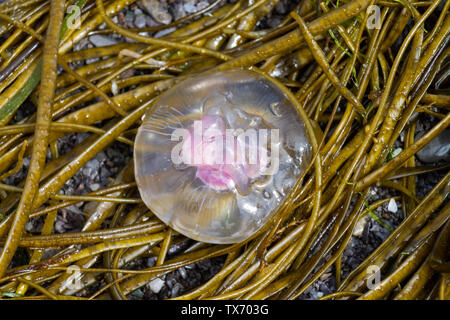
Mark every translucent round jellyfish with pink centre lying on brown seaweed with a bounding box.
[134,70,311,243]
